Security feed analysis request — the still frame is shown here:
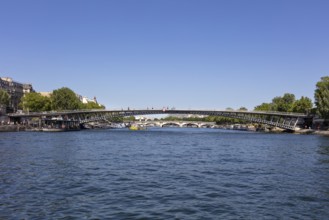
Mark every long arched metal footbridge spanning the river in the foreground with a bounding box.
[8,109,313,131]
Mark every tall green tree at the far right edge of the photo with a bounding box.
[314,76,329,119]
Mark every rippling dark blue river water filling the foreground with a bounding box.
[0,128,329,219]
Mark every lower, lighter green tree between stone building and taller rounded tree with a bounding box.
[20,92,51,112]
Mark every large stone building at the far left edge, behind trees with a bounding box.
[0,77,34,113]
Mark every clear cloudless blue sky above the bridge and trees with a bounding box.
[0,0,329,109]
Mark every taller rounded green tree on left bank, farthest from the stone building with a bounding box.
[51,87,82,110]
